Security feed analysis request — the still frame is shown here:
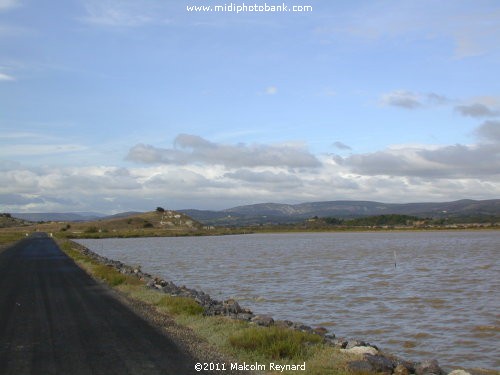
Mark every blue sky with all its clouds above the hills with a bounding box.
[0,0,500,213]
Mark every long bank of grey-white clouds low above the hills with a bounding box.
[0,120,500,212]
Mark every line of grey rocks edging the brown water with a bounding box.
[70,243,470,375]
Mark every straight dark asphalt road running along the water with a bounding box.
[0,234,196,375]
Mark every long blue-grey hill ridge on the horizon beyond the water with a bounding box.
[180,199,500,225]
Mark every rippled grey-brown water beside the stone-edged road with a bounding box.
[78,231,500,369]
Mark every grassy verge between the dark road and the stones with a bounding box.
[59,240,353,375]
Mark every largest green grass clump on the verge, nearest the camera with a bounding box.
[229,327,322,359]
